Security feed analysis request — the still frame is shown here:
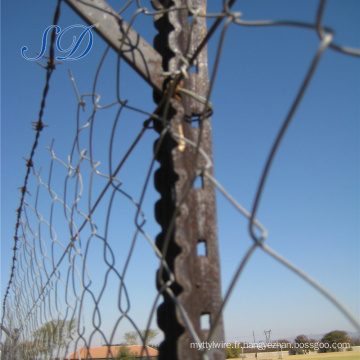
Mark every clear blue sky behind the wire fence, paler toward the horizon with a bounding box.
[1,0,360,341]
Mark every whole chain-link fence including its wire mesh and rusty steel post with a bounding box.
[1,0,360,360]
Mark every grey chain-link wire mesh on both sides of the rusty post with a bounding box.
[1,1,360,359]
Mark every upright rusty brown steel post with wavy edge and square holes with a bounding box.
[153,0,225,360]
